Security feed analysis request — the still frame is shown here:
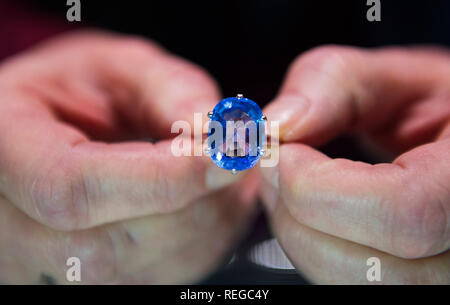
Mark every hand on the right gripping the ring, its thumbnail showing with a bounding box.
[261,46,450,284]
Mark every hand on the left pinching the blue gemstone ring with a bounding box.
[0,32,258,284]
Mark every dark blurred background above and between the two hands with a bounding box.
[0,0,450,284]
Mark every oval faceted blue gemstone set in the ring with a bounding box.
[208,97,265,171]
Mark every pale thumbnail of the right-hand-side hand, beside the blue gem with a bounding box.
[265,94,309,140]
